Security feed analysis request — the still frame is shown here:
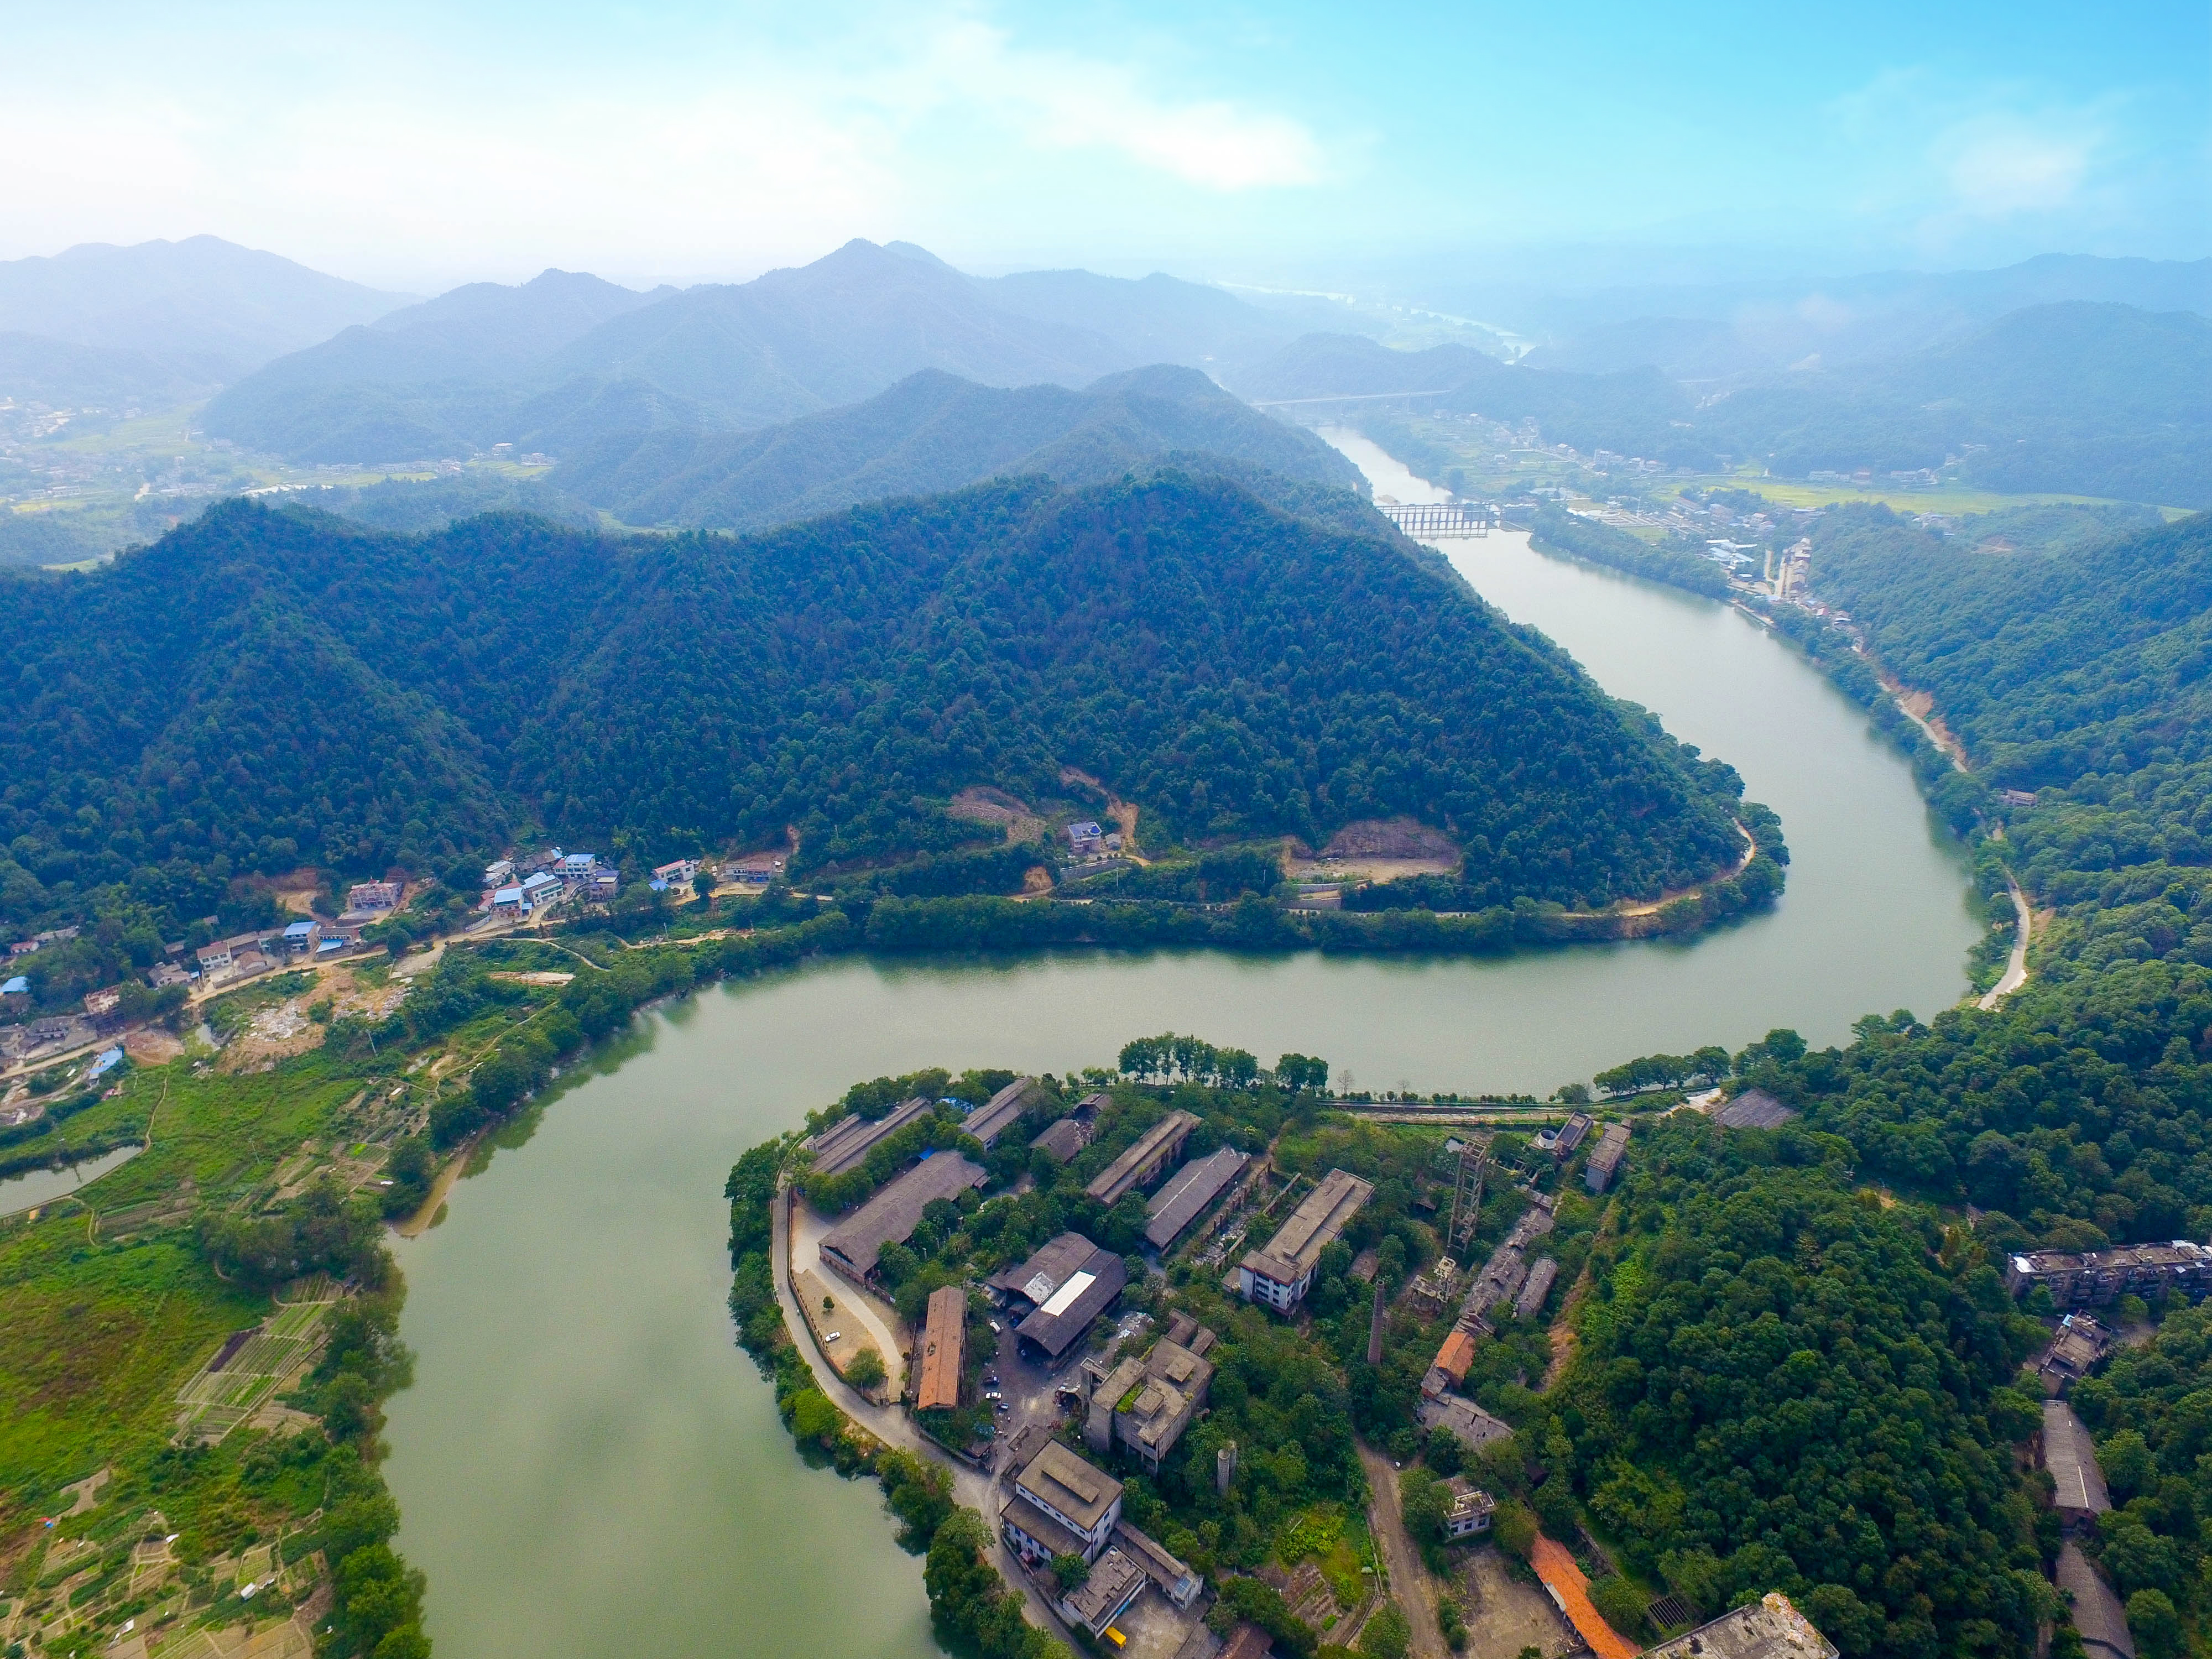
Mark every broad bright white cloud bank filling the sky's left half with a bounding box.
[0,11,1325,285]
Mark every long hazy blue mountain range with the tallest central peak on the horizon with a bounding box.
[208,241,1290,462]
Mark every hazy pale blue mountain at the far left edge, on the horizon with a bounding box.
[0,237,409,376]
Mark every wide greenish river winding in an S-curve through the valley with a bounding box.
[387,442,1975,1659]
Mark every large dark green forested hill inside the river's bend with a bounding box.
[0,473,1741,925]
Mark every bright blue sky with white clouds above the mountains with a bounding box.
[0,0,2212,290]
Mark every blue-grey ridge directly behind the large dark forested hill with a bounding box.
[551,365,1367,529]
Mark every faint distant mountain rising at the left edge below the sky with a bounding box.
[0,237,409,405]
